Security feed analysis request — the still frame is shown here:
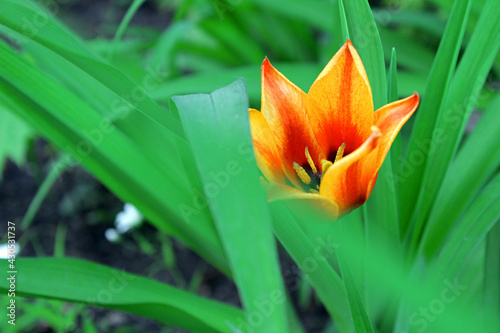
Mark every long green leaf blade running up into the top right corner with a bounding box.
[417,0,500,254]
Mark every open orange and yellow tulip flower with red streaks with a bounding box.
[249,40,419,217]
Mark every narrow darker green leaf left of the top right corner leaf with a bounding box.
[398,0,471,237]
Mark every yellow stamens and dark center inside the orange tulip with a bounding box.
[293,142,346,193]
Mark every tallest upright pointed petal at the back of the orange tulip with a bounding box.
[307,40,374,160]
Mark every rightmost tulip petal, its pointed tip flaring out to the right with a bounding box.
[375,93,420,168]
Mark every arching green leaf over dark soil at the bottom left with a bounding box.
[0,258,243,333]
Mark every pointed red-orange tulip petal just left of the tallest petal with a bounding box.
[261,58,319,186]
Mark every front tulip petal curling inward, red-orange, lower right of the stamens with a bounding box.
[319,127,382,214]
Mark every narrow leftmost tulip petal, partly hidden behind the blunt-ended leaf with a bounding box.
[249,109,285,184]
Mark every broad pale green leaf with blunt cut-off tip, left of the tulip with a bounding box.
[173,79,286,332]
